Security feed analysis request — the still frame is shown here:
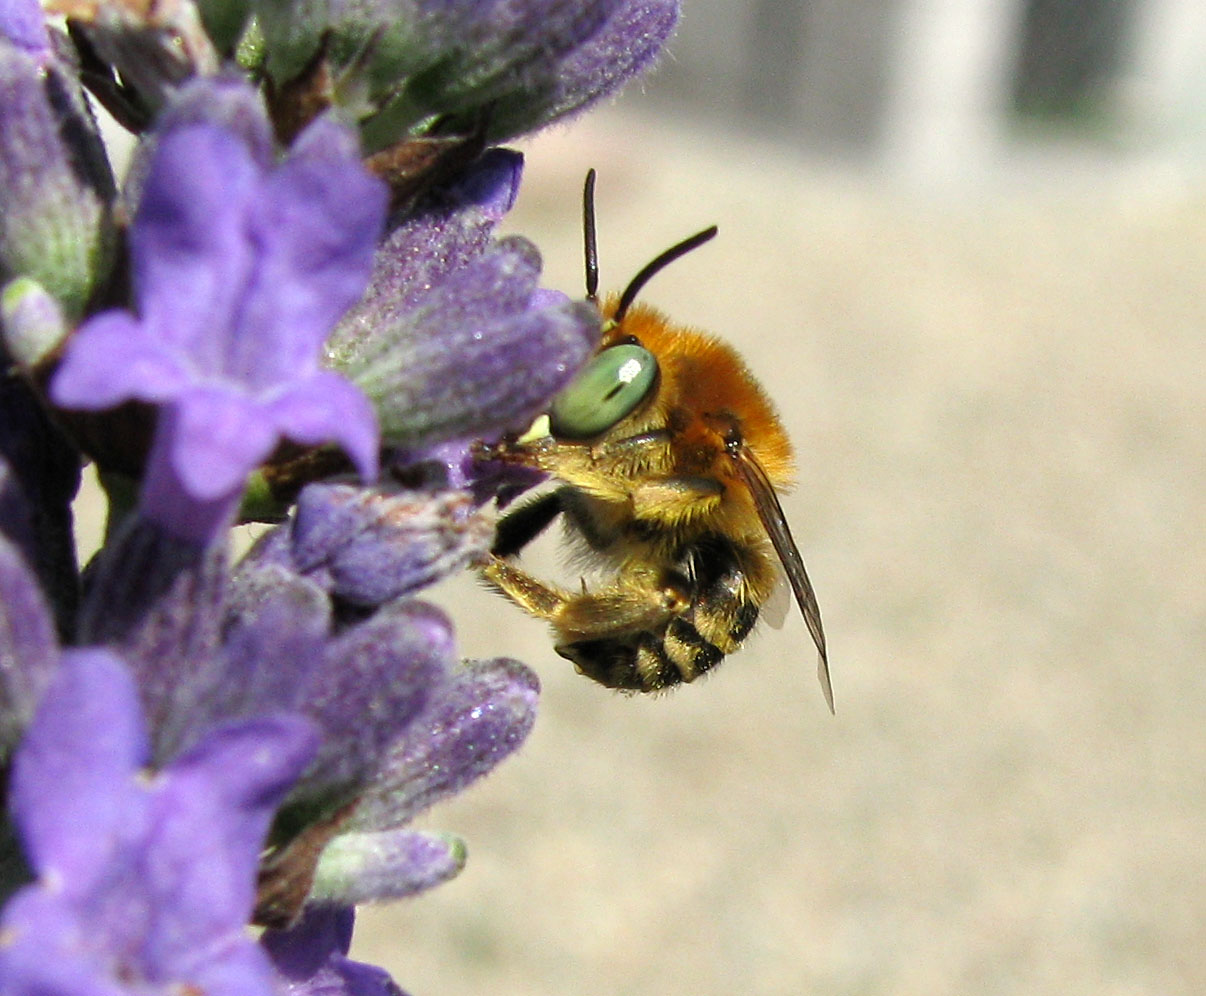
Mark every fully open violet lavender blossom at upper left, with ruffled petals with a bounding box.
[51,95,386,528]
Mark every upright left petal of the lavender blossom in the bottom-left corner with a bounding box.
[10,650,148,894]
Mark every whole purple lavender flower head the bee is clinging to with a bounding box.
[0,0,677,996]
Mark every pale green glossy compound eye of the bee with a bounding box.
[549,344,657,439]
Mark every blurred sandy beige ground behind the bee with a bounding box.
[353,23,1206,996]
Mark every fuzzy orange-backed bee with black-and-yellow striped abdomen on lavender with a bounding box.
[482,170,833,710]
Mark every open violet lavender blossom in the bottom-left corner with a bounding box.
[0,650,317,996]
